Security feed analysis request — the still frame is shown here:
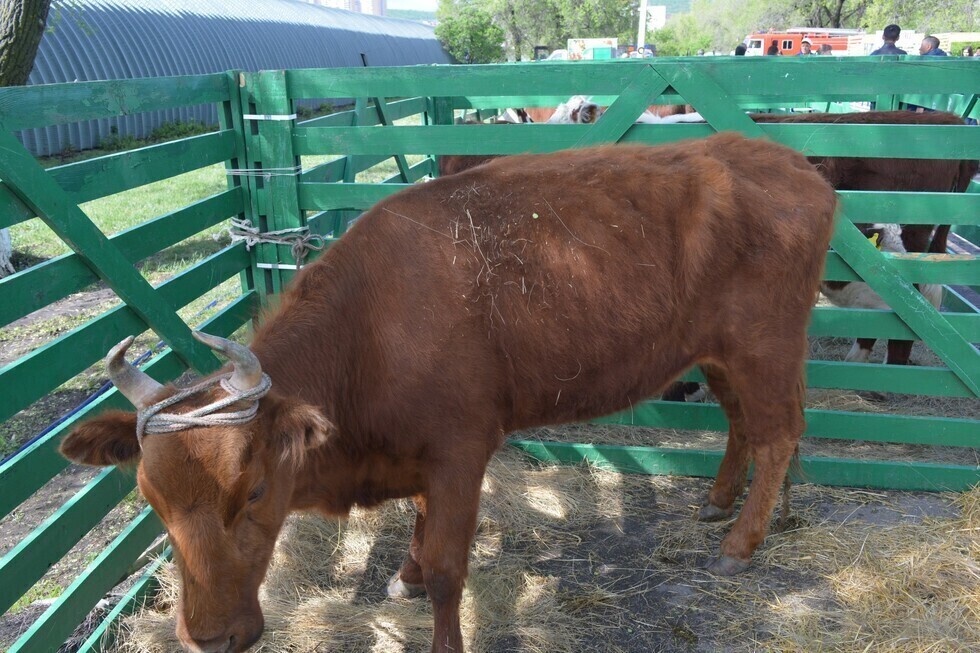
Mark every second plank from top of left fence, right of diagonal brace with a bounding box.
[48,129,236,204]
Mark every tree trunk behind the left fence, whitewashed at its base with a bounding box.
[0,0,51,277]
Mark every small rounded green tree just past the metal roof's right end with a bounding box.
[436,0,504,63]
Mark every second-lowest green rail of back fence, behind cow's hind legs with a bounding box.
[592,401,980,447]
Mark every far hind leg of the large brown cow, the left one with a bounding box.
[698,365,749,521]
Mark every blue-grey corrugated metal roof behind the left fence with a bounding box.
[21,0,450,155]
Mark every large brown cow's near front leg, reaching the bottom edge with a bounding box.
[419,466,485,653]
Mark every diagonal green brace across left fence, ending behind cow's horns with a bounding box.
[0,127,219,373]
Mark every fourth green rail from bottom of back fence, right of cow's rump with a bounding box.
[808,306,980,342]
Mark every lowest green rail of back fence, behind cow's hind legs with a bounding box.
[509,440,980,492]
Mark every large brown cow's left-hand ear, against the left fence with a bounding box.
[59,410,140,467]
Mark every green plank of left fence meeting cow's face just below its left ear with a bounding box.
[0,467,136,612]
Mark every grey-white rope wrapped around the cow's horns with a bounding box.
[136,372,272,449]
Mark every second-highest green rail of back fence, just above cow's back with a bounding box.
[293,123,980,159]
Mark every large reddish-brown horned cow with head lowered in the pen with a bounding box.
[61,134,836,653]
